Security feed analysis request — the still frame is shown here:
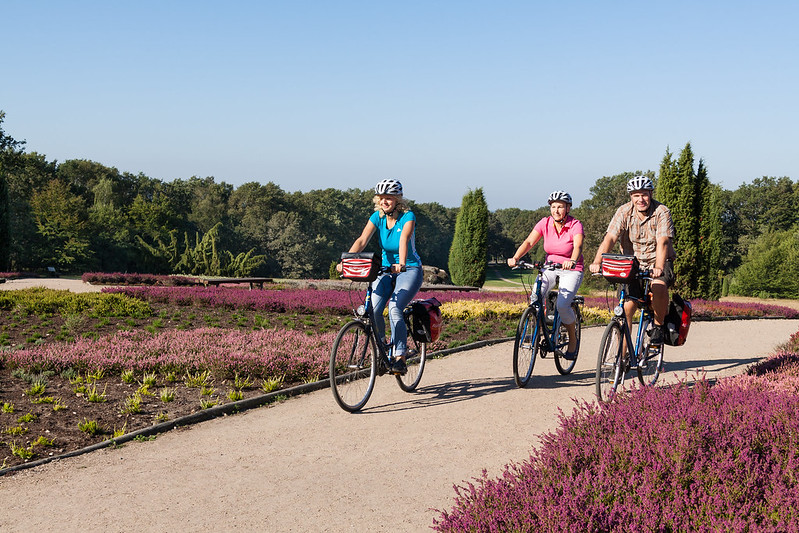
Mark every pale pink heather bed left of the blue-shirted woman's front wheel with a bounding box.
[2,328,336,383]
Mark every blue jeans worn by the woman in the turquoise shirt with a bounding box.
[372,266,423,357]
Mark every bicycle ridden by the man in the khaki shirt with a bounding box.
[595,255,663,401]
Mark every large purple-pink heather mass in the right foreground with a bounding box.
[434,353,799,532]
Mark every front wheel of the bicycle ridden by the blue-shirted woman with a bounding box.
[330,320,377,413]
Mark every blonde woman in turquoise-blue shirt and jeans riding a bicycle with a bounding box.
[339,179,423,374]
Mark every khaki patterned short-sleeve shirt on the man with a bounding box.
[608,200,675,268]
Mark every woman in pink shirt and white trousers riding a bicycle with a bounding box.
[508,191,583,359]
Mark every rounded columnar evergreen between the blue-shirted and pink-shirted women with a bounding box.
[449,188,488,287]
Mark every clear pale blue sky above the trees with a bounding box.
[0,0,799,210]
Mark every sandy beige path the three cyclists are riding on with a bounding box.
[0,294,799,532]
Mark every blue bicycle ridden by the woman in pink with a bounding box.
[513,261,584,387]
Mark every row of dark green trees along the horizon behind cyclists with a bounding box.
[0,111,799,297]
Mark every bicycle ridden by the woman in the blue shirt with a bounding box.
[330,267,434,413]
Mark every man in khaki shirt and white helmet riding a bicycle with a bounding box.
[588,176,675,345]
